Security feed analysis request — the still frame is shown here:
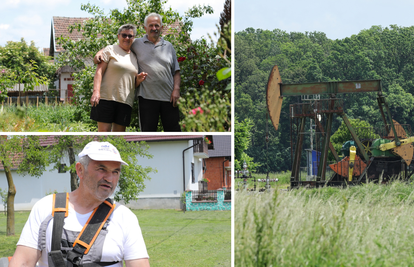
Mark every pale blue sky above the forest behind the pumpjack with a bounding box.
[234,0,414,40]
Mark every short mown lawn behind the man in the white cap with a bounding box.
[0,210,231,267]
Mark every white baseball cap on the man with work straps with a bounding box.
[78,141,128,165]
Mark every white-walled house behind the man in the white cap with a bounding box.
[0,135,218,210]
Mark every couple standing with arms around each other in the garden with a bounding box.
[91,13,181,132]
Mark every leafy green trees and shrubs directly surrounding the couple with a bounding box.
[59,0,230,131]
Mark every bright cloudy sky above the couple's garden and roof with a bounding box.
[0,0,225,48]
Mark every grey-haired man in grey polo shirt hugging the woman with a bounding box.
[94,13,181,132]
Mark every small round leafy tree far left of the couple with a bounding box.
[0,38,56,104]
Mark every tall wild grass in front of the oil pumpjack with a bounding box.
[234,181,414,266]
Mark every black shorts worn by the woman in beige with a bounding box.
[90,99,132,126]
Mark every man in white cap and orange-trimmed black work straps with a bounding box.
[10,141,149,267]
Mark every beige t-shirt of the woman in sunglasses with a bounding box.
[100,45,138,107]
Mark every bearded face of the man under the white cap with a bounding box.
[83,160,121,201]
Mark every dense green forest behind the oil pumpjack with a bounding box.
[235,25,414,172]
